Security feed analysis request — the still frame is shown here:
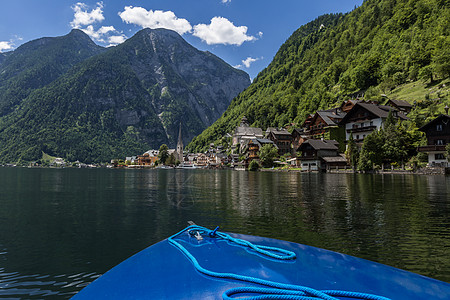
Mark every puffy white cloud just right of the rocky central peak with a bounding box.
[193,17,256,46]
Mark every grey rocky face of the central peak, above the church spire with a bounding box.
[116,29,250,146]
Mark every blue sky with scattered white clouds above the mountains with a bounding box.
[0,0,363,80]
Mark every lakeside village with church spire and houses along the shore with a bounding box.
[118,100,450,172]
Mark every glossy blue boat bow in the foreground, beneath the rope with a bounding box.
[73,229,450,300]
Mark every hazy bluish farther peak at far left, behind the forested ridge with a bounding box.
[0,29,105,116]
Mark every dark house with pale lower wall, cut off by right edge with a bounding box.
[417,115,450,166]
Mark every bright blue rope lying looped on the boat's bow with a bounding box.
[167,225,390,300]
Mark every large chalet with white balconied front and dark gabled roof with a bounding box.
[339,101,408,144]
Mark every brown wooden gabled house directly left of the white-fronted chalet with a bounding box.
[303,108,347,151]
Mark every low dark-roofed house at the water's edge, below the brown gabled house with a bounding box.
[297,139,347,171]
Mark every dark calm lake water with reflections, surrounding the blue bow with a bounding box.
[0,168,450,299]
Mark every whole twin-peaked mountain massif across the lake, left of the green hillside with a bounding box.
[0,29,250,162]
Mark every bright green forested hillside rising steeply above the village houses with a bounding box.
[188,0,450,151]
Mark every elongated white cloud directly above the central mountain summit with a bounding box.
[119,6,192,35]
